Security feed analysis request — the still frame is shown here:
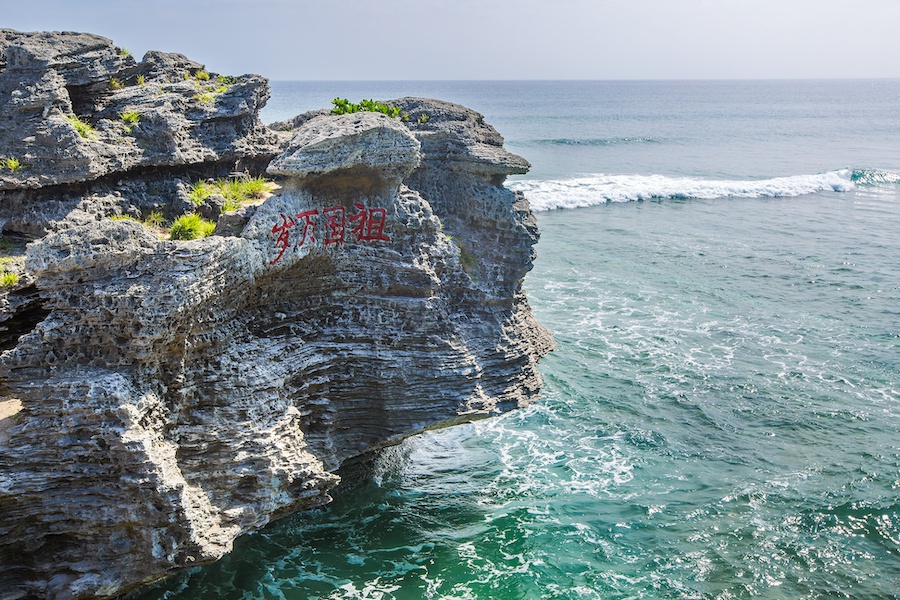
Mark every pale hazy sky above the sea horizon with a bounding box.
[7,0,900,80]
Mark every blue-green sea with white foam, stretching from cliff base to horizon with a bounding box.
[140,80,900,600]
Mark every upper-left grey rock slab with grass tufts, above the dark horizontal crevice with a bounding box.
[0,30,277,198]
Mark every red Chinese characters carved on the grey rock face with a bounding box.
[269,204,391,265]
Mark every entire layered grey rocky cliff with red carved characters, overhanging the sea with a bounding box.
[0,30,553,600]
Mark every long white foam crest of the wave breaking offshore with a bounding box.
[509,169,856,210]
